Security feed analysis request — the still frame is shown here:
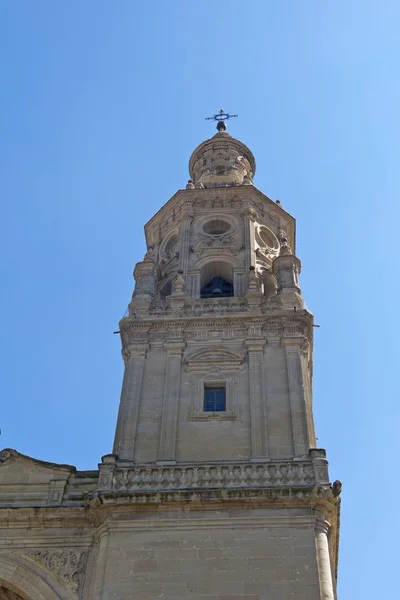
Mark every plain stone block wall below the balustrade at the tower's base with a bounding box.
[95,510,321,600]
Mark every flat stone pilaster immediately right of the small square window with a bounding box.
[245,339,267,459]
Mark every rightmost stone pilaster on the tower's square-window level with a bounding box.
[282,338,310,457]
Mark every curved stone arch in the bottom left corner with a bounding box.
[0,552,76,600]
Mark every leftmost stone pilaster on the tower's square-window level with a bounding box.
[113,344,149,460]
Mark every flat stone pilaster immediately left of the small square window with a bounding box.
[158,340,185,461]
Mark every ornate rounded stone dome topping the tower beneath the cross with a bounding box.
[189,128,256,188]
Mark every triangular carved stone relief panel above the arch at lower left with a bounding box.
[19,550,86,593]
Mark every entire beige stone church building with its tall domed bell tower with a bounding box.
[0,120,341,600]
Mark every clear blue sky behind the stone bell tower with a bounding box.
[0,0,400,600]
